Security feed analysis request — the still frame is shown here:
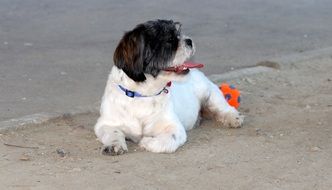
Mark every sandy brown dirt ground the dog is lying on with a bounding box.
[0,57,332,190]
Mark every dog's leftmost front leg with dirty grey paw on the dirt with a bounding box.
[95,123,128,156]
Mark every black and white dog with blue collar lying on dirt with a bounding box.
[94,20,243,155]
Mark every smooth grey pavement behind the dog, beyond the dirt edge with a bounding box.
[0,0,332,121]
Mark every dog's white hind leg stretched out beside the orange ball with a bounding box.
[203,81,244,128]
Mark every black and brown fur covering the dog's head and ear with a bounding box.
[113,20,180,82]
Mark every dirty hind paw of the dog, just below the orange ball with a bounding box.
[217,110,244,128]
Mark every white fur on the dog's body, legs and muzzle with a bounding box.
[95,38,243,155]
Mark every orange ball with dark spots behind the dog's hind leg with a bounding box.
[219,83,241,108]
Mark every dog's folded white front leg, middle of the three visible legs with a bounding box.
[139,121,187,153]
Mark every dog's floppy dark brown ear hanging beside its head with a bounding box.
[113,31,146,82]
